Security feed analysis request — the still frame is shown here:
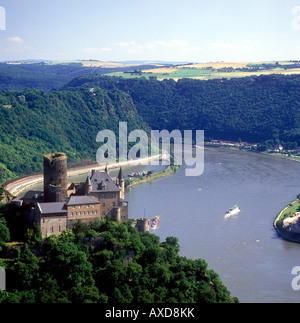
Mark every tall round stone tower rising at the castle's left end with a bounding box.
[44,153,68,202]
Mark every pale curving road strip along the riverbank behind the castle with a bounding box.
[3,154,166,196]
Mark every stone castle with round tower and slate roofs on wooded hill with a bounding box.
[30,153,149,237]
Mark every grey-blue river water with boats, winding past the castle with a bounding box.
[22,148,300,303]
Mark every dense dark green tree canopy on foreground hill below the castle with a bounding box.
[0,220,238,304]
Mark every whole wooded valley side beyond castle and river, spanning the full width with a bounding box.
[0,74,300,186]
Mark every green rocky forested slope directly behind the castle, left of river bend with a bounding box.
[0,89,148,183]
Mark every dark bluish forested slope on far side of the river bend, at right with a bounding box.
[67,75,300,144]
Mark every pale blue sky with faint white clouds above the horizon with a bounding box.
[0,0,300,63]
